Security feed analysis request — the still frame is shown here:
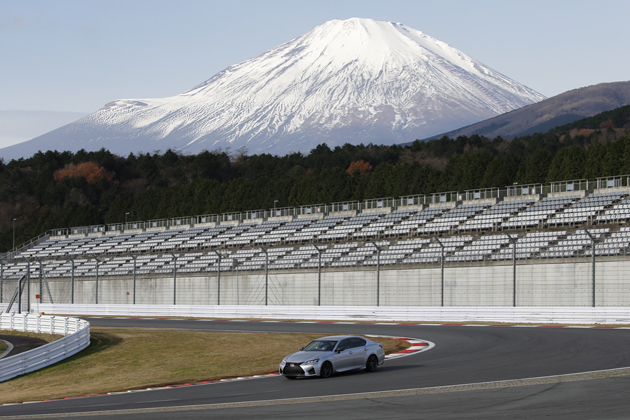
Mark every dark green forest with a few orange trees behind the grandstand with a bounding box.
[0,106,630,251]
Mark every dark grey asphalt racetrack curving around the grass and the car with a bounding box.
[0,318,630,420]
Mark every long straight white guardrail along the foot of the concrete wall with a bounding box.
[39,304,630,325]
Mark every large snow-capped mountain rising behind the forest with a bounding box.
[0,18,544,156]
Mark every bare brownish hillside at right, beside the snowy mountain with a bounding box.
[418,82,630,140]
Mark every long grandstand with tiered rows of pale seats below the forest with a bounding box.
[0,176,630,301]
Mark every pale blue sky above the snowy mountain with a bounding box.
[0,0,630,144]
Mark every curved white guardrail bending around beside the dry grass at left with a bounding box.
[0,313,90,382]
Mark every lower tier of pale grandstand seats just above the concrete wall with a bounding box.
[2,227,630,278]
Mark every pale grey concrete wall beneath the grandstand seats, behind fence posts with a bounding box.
[3,259,630,309]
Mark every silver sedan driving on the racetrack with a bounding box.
[280,335,385,379]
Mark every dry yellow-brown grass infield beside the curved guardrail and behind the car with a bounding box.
[0,328,409,403]
